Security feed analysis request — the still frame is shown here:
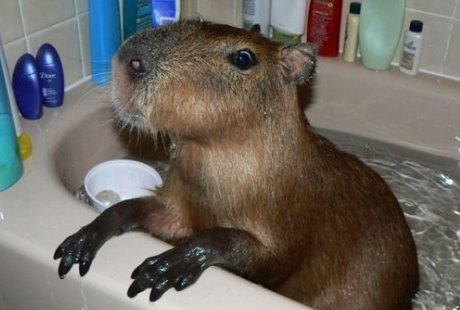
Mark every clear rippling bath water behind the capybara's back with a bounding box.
[318,130,460,310]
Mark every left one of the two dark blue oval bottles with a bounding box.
[13,53,43,120]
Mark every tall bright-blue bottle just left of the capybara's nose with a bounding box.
[88,0,121,85]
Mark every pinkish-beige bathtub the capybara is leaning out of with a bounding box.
[0,58,460,310]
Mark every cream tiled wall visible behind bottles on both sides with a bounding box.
[0,0,460,85]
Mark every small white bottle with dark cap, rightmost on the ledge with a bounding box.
[399,20,423,75]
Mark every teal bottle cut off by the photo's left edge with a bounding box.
[0,50,24,192]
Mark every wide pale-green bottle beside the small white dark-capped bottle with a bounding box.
[359,0,406,71]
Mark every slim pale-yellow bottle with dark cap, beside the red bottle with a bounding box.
[343,2,361,62]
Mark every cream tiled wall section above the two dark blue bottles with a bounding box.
[0,0,89,86]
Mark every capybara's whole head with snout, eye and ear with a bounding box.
[113,21,316,139]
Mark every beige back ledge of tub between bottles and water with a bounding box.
[306,57,460,160]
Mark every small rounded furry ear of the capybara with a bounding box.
[281,43,317,85]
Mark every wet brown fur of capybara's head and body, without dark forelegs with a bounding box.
[114,22,417,309]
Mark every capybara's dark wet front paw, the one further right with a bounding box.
[128,248,208,301]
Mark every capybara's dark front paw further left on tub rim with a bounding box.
[54,226,104,278]
